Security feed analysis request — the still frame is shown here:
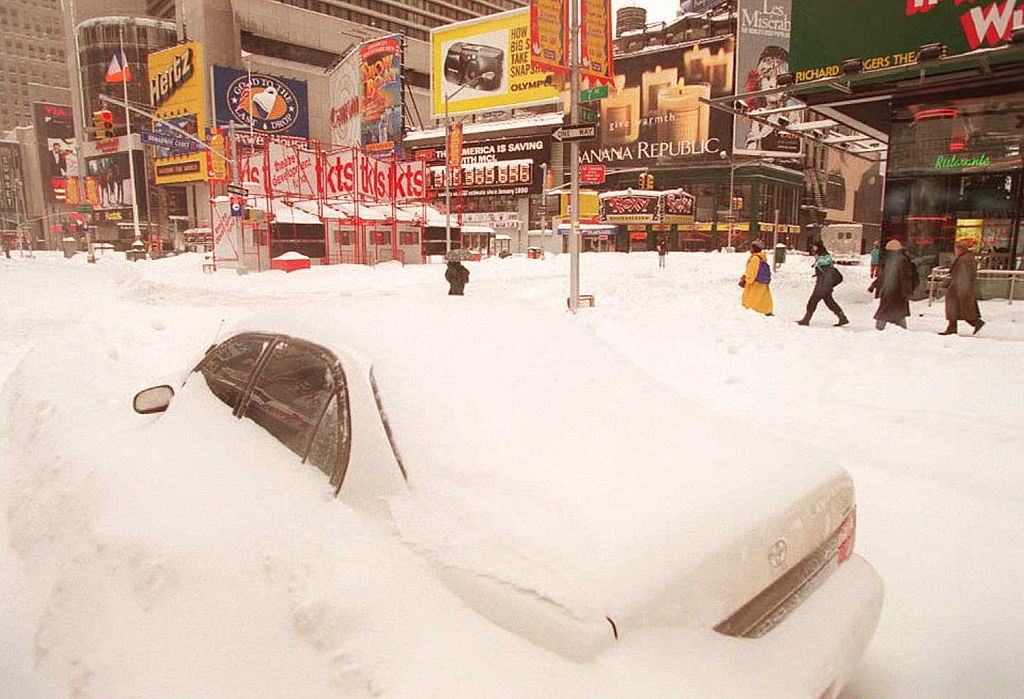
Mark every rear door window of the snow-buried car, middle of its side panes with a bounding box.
[245,340,335,457]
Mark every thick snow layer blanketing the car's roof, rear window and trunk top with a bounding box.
[228,297,841,616]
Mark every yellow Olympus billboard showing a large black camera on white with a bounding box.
[430,7,561,118]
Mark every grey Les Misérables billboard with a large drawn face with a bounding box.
[733,0,803,158]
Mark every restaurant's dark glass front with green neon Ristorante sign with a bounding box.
[883,95,1024,278]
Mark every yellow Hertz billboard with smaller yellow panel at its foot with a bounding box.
[148,41,207,184]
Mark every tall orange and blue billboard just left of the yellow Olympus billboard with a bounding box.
[359,34,403,158]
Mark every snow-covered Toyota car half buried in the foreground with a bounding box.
[128,301,882,699]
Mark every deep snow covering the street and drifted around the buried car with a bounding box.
[0,248,1024,699]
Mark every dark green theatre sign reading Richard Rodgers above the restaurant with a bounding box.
[790,0,1024,83]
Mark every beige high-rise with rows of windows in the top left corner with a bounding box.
[0,0,69,131]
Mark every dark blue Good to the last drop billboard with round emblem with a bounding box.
[213,65,309,138]
